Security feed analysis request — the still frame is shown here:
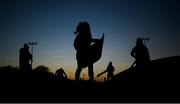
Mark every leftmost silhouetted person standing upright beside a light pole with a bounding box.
[19,43,32,71]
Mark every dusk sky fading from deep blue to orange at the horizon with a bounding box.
[0,0,180,80]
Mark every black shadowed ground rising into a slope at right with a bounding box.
[0,56,180,103]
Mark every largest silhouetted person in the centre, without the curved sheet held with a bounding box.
[74,22,99,80]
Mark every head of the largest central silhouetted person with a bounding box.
[74,21,90,35]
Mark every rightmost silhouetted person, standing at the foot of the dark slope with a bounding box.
[130,38,150,69]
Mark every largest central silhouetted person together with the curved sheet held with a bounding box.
[74,21,104,80]
